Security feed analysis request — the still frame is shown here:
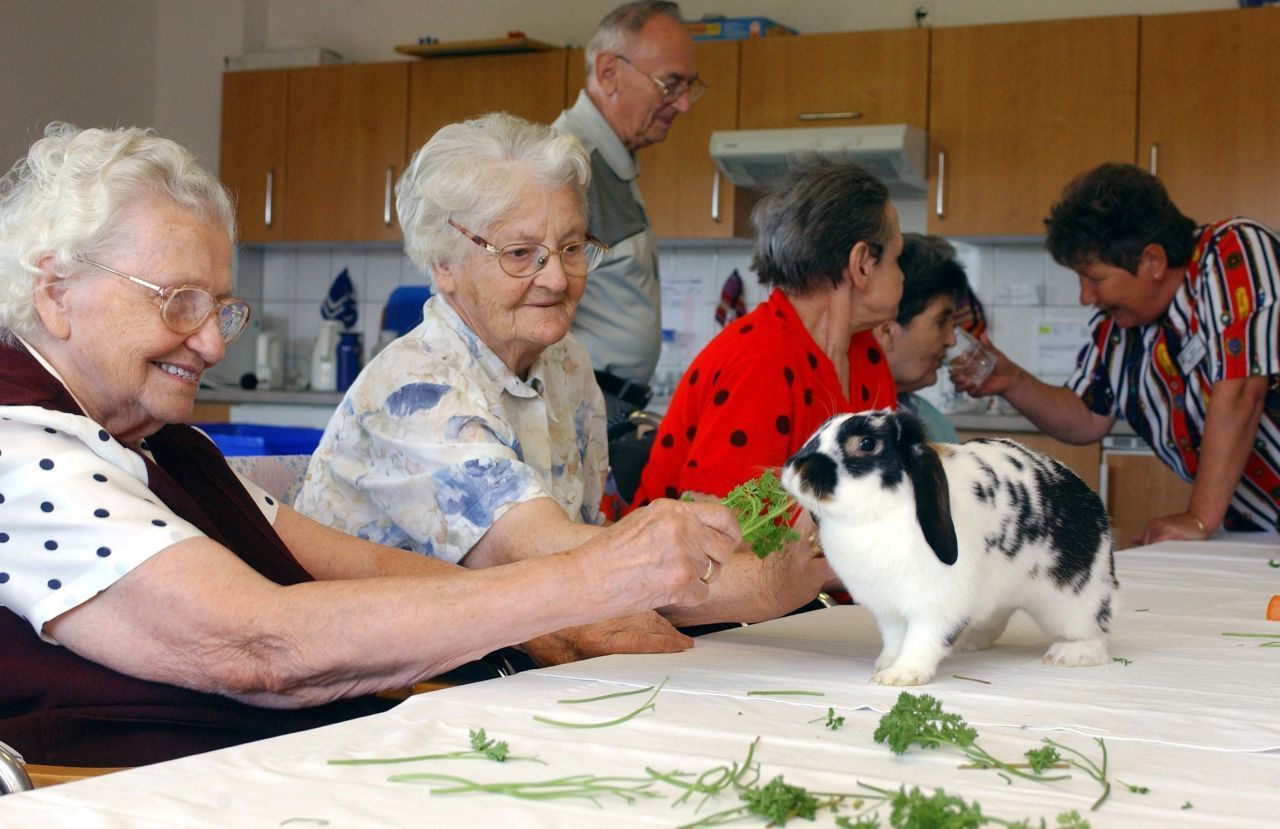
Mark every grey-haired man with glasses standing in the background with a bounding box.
[553,0,707,423]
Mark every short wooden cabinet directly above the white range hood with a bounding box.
[737,29,929,129]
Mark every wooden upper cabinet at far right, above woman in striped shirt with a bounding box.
[1138,8,1280,228]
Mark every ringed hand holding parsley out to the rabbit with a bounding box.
[581,499,742,613]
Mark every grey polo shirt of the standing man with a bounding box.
[552,91,662,384]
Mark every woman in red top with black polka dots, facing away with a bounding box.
[634,159,902,505]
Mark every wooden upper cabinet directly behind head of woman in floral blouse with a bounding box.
[408,49,567,150]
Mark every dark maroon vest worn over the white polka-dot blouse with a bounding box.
[0,344,390,766]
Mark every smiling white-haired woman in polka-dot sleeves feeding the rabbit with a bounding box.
[0,125,740,765]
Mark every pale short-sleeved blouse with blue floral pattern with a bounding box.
[296,297,608,563]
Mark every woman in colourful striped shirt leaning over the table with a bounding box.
[965,164,1280,544]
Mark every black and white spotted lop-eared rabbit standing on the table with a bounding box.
[782,409,1119,686]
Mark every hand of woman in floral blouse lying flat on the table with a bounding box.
[521,610,694,668]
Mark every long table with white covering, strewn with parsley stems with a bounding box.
[0,536,1280,829]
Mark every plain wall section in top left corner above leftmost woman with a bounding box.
[0,0,158,170]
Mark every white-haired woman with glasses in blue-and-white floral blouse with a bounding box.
[297,114,829,664]
